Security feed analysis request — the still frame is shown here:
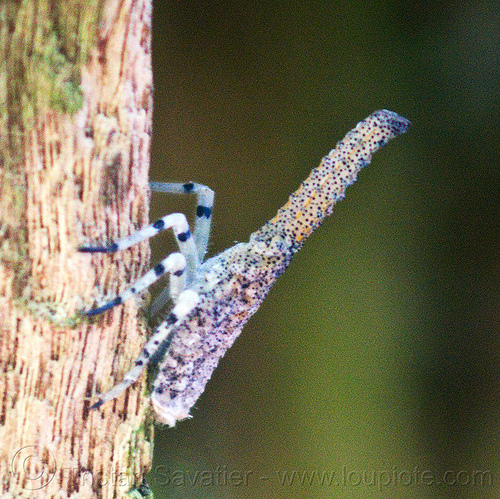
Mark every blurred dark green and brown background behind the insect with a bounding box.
[148,0,500,499]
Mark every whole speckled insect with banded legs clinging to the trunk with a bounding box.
[79,110,410,426]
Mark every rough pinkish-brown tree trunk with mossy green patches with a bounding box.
[0,0,152,499]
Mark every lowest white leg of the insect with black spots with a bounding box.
[91,289,200,409]
